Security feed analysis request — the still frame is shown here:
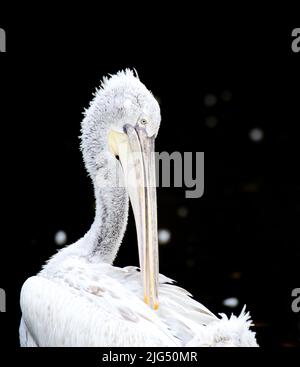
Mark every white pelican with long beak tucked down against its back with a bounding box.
[19,69,257,347]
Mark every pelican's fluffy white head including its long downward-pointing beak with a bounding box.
[81,70,161,309]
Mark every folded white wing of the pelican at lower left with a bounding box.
[21,276,178,347]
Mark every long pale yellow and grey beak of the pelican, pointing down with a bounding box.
[109,125,158,310]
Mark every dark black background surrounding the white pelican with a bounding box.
[0,8,300,356]
